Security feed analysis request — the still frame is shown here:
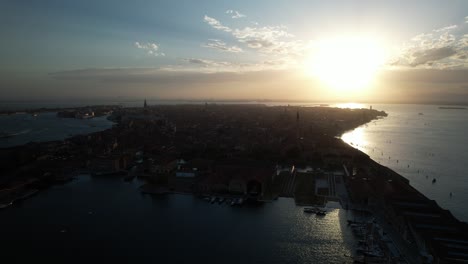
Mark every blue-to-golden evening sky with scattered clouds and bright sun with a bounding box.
[0,0,468,103]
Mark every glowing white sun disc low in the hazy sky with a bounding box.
[304,37,385,92]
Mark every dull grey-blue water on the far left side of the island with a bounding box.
[0,112,113,148]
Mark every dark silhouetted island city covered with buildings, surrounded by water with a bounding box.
[0,103,468,263]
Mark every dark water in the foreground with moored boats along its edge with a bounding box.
[0,176,354,263]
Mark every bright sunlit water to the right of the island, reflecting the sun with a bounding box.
[342,105,468,222]
